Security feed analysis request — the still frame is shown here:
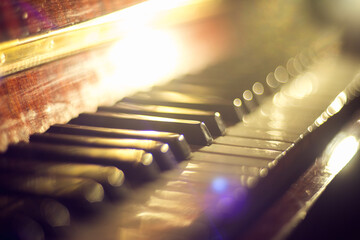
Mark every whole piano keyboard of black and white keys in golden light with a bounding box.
[0,49,358,240]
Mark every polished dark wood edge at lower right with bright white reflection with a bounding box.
[241,113,360,240]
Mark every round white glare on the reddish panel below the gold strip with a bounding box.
[99,27,181,98]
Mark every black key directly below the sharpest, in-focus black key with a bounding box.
[47,124,191,161]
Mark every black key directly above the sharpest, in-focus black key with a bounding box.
[98,102,225,137]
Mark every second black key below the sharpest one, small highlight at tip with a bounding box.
[30,133,176,170]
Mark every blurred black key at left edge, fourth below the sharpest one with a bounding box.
[0,159,127,198]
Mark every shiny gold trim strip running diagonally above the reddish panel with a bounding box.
[0,0,222,77]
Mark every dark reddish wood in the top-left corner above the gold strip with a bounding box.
[0,0,144,41]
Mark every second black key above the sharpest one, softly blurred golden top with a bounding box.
[121,91,247,125]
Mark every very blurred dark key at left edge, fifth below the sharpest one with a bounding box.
[0,173,104,208]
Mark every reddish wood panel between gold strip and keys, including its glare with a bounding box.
[0,11,229,151]
